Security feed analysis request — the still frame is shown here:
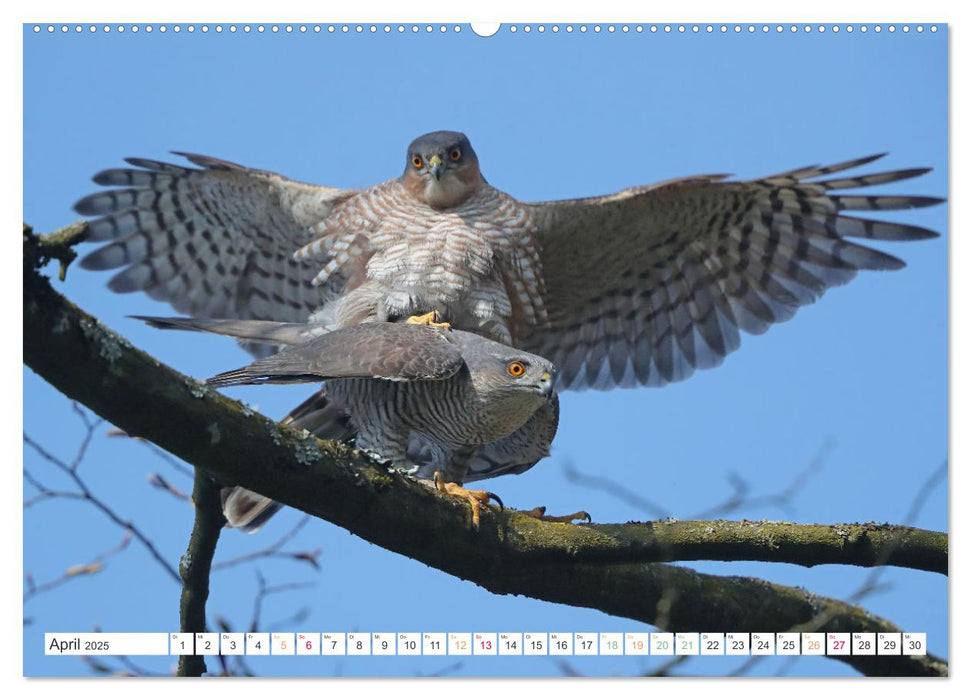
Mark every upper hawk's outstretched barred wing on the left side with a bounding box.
[74,153,352,321]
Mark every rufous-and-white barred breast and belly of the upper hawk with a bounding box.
[296,180,546,342]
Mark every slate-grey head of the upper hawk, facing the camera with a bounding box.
[402,131,485,209]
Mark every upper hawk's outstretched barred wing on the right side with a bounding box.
[516,156,943,389]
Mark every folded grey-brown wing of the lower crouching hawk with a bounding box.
[208,322,464,386]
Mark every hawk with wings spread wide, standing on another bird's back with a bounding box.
[75,131,943,389]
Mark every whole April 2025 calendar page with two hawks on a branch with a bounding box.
[22,8,949,678]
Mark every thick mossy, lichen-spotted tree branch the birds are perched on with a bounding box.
[24,230,947,675]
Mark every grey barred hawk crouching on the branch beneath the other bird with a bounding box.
[179,317,559,531]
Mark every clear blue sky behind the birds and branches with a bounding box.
[24,25,948,675]
